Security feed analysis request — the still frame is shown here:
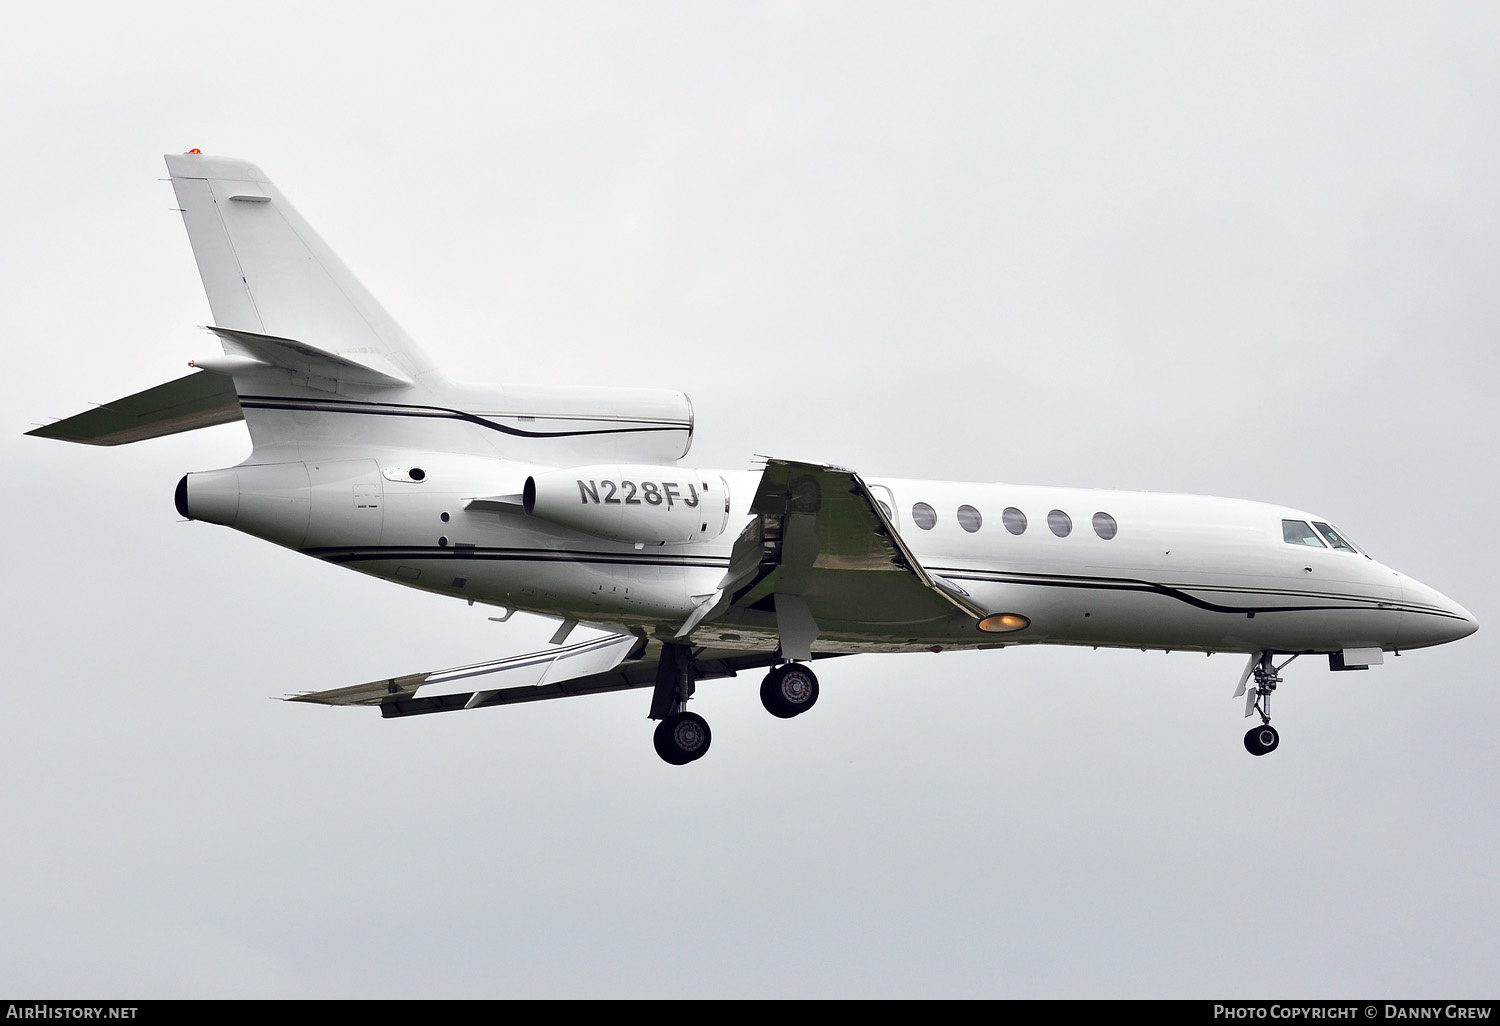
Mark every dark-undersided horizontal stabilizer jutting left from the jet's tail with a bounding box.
[26,374,245,446]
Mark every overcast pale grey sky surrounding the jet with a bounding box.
[0,0,1500,998]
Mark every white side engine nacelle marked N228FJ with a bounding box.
[522,464,729,545]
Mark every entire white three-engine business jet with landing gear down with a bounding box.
[30,150,1478,765]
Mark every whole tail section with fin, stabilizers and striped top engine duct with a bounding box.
[30,153,693,467]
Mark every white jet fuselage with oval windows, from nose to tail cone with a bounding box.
[178,453,1475,653]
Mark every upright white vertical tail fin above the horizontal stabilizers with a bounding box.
[167,153,441,386]
